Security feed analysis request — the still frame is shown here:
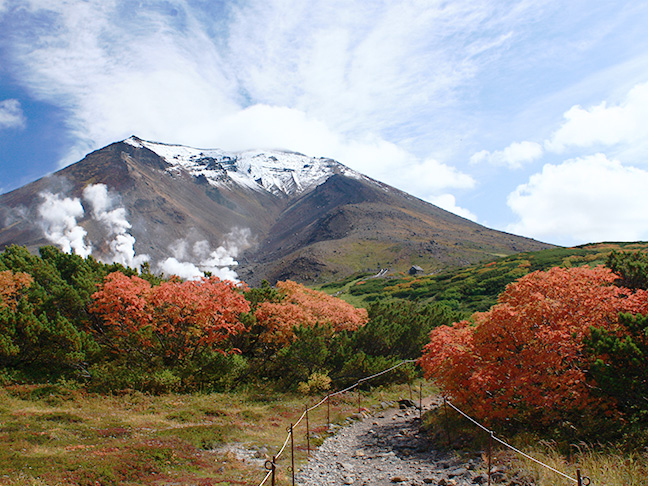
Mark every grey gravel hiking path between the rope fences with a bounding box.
[296,398,530,486]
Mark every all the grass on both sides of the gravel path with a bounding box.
[0,385,648,486]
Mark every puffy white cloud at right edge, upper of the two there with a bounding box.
[545,83,648,156]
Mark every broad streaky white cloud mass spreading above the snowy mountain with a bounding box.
[0,0,540,218]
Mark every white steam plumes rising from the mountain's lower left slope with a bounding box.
[37,184,251,281]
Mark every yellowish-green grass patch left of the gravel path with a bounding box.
[0,385,416,486]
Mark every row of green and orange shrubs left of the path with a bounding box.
[0,246,458,393]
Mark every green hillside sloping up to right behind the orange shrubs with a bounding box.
[319,242,648,315]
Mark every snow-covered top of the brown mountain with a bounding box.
[124,137,362,196]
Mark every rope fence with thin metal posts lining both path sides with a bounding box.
[253,359,591,486]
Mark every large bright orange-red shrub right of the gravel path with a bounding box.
[420,267,648,421]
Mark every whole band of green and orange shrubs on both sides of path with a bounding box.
[0,246,648,440]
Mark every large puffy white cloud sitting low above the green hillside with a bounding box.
[507,154,648,244]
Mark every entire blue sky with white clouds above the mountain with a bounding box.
[0,0,648,245]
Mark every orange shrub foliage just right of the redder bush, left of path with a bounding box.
[255,280,368,344]
